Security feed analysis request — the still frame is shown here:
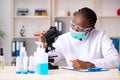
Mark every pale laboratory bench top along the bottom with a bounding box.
[0,66,120,80]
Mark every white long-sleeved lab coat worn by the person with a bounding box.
[53,29,120,68]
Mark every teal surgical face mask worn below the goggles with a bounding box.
[70,27,85,40]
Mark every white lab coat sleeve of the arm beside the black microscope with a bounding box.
[52,37,64,64]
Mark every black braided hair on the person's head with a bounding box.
[74,7,97,28]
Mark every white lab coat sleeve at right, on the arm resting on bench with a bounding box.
[91,33,120,68]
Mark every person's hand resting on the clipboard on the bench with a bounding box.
[71,59,95,69]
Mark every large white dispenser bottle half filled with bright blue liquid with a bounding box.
[36,48,48,75]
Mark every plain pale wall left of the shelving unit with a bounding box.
[0,0,11,65]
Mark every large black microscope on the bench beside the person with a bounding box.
[41,26,58,69]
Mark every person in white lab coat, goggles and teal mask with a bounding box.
[40,7,120,69]
